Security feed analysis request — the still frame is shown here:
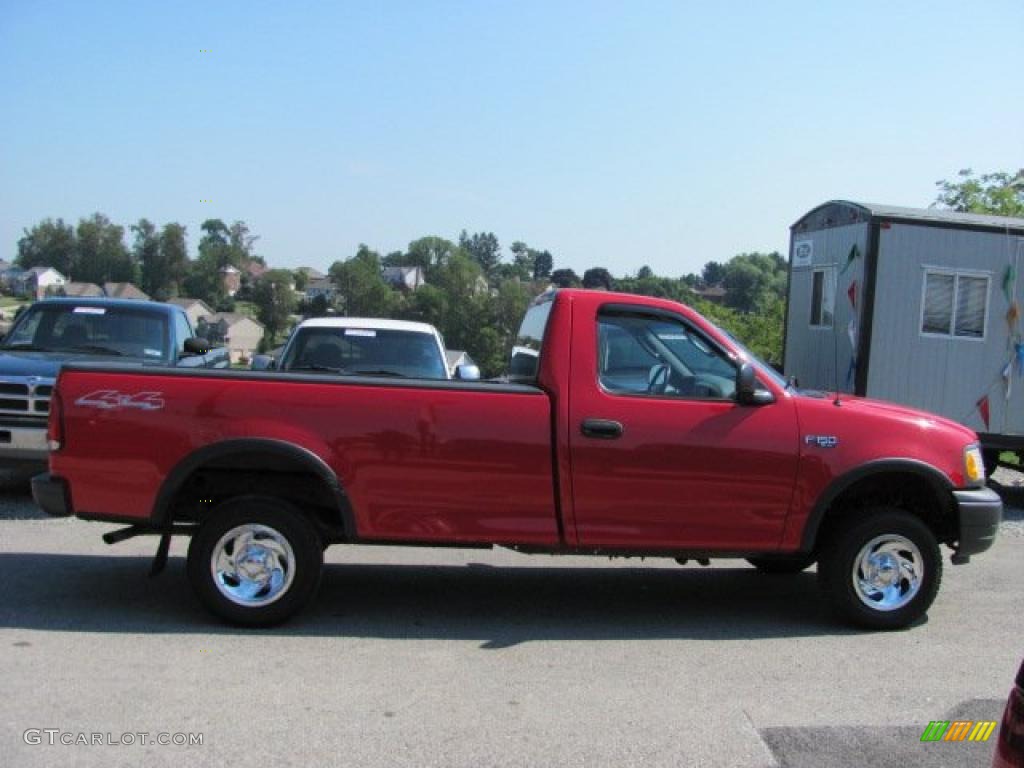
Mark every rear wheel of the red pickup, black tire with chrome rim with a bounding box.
[187,496,324,627]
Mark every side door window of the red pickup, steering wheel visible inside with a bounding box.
[597,314,736,399]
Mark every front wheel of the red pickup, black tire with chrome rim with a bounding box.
[818,507,942,630]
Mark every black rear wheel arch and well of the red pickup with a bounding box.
[151,437,357,541]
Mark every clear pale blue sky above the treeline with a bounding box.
[0,0,1024,275]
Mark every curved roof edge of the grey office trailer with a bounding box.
[791,200,1024,234]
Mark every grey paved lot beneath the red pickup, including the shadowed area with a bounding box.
[0,471,1024,768]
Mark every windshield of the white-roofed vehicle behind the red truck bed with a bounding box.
[281,328,449,379]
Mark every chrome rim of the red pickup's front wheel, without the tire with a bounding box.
[851,534,925,611]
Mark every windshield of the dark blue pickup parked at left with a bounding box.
[3,304,168,359]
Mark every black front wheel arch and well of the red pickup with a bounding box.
[801,459,956,552]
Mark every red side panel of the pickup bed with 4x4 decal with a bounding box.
[51,364,560,545]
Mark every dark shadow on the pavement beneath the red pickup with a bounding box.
[0,553,897,649]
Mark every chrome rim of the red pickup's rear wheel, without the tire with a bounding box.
[210,523,295,608]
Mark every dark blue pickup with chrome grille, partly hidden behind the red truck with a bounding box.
[0,299,228,482]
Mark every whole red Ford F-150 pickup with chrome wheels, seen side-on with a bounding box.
[33,290,1002,628]
